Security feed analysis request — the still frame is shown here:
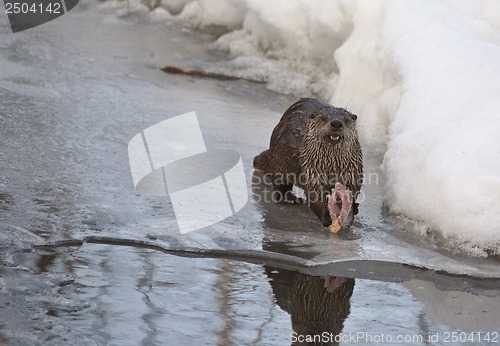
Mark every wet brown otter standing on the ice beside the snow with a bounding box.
[253,98,363,228]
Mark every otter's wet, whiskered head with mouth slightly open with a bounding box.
[308,107,357,145]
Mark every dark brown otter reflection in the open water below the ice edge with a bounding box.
[265,266,354,345]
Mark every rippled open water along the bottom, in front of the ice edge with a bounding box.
[2,244,499,345]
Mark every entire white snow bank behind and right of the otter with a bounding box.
[154,0,500,254]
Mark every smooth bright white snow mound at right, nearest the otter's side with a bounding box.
[378,1,500,251]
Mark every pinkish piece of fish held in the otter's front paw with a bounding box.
[328,182,353,233]
